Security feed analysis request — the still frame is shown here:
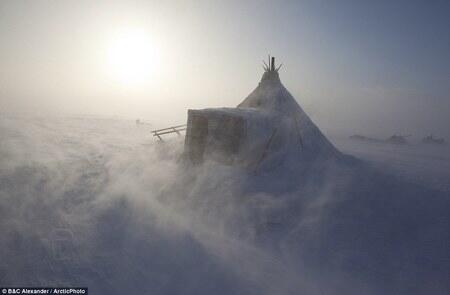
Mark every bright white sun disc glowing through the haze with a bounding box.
[107,29,159,85]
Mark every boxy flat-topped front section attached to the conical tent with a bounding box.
[185,108,274,166]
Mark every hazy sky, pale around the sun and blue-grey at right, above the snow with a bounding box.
[0,0,450,136]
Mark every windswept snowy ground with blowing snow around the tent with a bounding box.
[0,115,450,294]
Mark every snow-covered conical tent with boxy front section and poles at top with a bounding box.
[185,57,340,167]
